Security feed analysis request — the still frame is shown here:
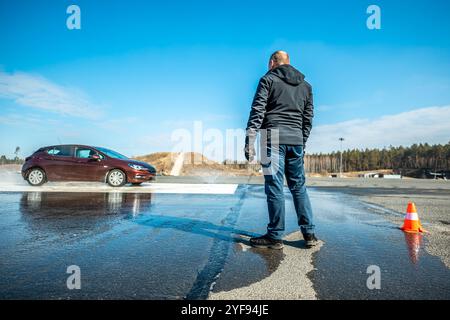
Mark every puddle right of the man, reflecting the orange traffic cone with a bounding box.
[309,192,450,299]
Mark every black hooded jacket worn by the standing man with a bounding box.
[247,65,313,145]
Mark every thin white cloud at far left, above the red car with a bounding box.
[0,71,100,119]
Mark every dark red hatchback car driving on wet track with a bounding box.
[22,145,156,187]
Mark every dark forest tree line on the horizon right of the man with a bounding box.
[305,142,450,173]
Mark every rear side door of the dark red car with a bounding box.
[43,146,75,181]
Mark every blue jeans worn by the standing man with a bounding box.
[263,145,314,239]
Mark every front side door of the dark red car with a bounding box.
[73,147,104,181]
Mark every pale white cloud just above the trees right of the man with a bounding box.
[306,106,450,153]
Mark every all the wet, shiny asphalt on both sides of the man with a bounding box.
[0,185,450,299]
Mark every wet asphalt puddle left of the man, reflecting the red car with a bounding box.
[0,187,283,299]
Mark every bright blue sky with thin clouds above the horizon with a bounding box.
[0,0,450,156]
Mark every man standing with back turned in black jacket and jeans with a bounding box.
[245,51,317,249]
